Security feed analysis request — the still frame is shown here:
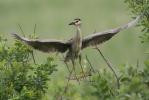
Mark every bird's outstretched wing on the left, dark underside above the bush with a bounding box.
[12,31,70,53]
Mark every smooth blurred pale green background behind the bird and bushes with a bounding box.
[0,0,146,98]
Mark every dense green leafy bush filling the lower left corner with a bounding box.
[0,34,56,100]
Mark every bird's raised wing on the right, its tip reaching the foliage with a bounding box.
[82,14,142,49]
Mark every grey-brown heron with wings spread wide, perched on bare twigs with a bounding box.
[11,15,142,81]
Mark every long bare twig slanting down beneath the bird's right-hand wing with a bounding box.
[94,46,120,89]
